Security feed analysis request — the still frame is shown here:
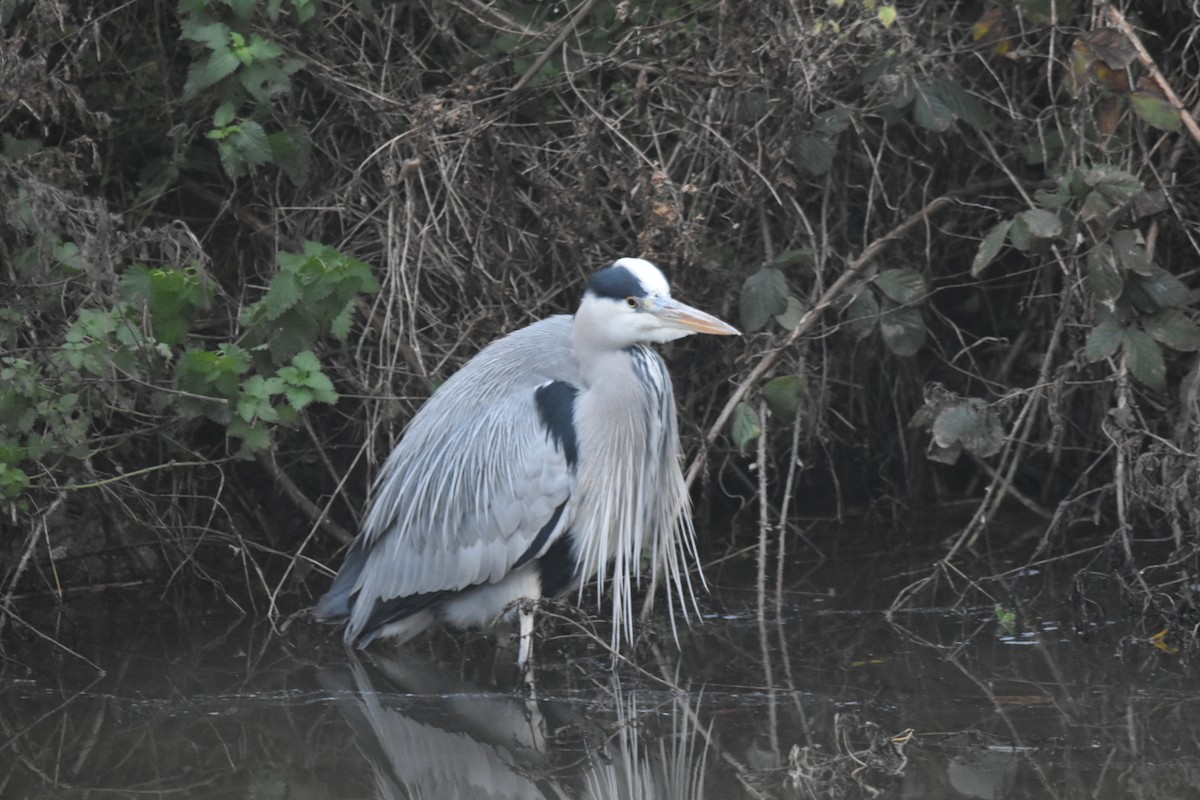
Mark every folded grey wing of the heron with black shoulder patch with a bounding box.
[350,317,578,630]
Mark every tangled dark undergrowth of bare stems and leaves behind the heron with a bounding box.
[0,0,1200,652]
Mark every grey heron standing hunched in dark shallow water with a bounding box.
[314,258,738,661]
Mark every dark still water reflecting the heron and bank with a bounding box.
[0,525,1200,800]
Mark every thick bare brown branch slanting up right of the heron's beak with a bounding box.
[686,178,1009,488]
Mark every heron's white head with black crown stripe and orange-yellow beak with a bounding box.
[576,258,740,348]
